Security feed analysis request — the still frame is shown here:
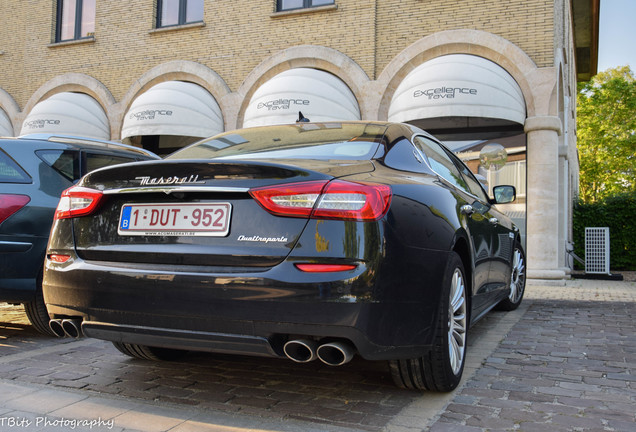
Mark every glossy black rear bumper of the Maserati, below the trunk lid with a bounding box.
[43,250,445,360]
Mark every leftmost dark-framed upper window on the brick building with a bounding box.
[56,0,95,42]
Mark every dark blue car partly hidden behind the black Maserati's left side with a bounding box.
[0,134,158,334]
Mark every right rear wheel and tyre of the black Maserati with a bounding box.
[389,252,468,392]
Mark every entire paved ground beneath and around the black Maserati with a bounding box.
[0,280,636,432]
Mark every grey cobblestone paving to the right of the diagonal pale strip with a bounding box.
[422,281,636,432]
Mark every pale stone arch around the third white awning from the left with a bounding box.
[116,60,232,134]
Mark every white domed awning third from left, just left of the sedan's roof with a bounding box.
[121,81,224,139]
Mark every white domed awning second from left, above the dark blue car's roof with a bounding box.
[20,92,110,140]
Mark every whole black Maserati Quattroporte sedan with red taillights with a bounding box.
[43,122,525,391]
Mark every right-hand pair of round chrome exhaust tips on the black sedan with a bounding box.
[283,339,355,366]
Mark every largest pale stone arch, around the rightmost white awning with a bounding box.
[375,30,555,120]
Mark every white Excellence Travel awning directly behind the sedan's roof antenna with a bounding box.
[243,68,360,127]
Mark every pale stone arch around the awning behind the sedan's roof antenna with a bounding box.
[236,45,372,130]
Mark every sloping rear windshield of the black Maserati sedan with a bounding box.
[166,123,386,160]
